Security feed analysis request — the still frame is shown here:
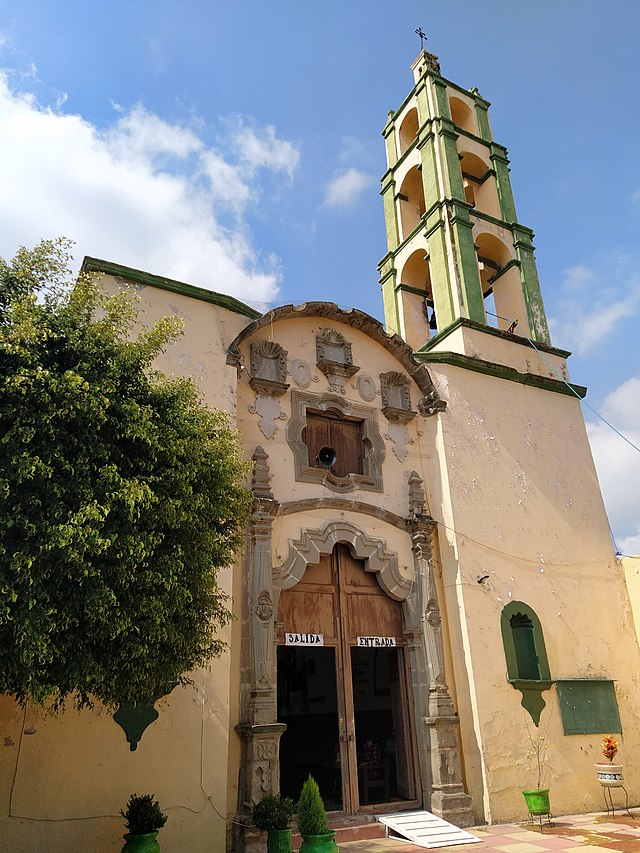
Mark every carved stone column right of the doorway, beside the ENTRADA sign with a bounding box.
[407,472,474,826]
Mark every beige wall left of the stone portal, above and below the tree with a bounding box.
[0,276,250,853]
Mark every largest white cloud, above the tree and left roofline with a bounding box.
[0,74,298,302]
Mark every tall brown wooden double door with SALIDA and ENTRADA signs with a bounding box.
[277,545,416,814]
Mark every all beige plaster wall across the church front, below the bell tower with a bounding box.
[0,280,640,853]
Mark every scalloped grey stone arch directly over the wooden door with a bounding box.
[273,521,413,601]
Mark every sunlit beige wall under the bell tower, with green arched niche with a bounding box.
[424,366,640,822]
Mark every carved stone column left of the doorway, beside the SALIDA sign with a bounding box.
[234,447,286,851]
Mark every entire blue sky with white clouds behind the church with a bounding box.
[0,0,640,554]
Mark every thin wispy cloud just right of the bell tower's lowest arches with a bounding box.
[549,252,640,355]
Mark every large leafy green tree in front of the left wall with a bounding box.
[0,240,250,710]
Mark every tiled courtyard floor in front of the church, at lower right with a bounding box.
[339,809,640,853]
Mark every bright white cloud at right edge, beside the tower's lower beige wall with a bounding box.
[587,377,640,553]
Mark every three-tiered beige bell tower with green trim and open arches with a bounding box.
[379,50,550,354]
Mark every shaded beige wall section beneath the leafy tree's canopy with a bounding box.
[0,655,235,853]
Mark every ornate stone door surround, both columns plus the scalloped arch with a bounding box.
[237,460,473,851]
